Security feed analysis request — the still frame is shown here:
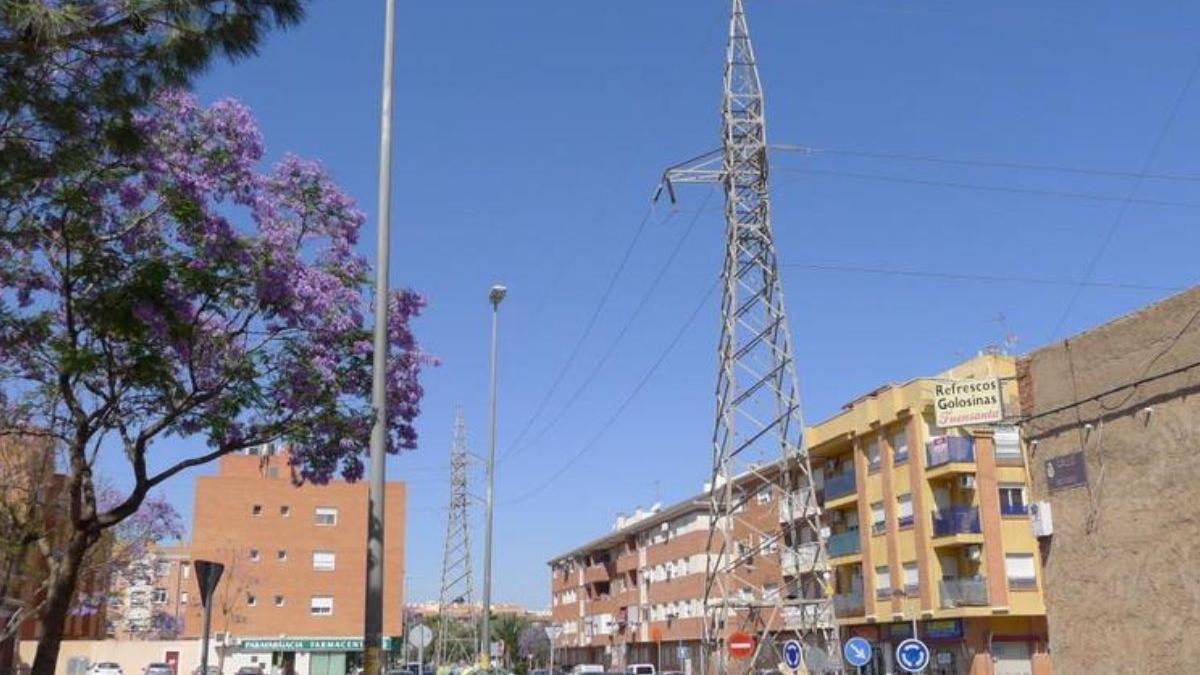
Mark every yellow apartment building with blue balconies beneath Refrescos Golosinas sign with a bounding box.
[808,354,1050,675]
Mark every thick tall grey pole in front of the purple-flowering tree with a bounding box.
[362,0,396,675]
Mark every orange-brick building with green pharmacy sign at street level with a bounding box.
[175,448,406,675]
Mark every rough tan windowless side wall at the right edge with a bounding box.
[1020,284,1200,675]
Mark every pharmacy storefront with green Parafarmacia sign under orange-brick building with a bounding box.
[232,638,402,675]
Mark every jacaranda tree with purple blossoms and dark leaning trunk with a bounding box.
[0,90,427,675]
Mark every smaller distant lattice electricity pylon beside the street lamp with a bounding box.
[436,407,479,665]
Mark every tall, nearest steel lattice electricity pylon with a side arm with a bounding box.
[664,0,841,675]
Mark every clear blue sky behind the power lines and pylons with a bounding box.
[105,0,1200,607]
